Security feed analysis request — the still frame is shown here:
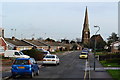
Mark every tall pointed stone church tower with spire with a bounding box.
[82,7,90,44]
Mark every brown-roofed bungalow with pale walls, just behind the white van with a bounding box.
[4,37,33,51]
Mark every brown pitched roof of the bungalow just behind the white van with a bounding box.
[4,38,31,46]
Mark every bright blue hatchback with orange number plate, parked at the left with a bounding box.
[11,58,39,78]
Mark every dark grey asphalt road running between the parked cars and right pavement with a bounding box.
[8,52,87,80]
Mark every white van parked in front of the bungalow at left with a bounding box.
[4,50,30,58]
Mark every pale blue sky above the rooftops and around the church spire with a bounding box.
[1,2,118,40]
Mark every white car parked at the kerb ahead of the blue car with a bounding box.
[43,54,59,65]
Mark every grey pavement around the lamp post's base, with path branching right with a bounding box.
[88,52,115,80]
